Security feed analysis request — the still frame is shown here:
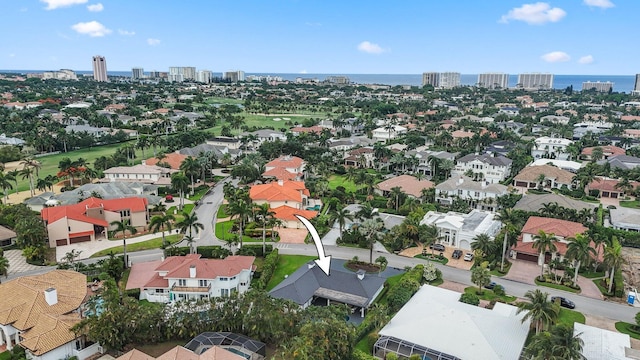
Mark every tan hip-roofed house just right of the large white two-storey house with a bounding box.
[513,165,575,192]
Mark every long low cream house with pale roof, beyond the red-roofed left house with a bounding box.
[101,161,178,186]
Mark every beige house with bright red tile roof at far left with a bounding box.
[40,197,149,247]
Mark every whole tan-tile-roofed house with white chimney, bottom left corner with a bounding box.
[0,270,100,360]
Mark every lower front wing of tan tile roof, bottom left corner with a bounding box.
[20,313,80,356]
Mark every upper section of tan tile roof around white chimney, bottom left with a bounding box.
[0,270,87,331]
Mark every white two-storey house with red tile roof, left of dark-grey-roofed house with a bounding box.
[127,254,256,303]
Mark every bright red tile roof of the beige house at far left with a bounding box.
[40,197,149,227]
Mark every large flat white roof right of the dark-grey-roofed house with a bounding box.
[379,285,529,360]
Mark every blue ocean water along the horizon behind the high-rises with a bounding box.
[0,70,635,93]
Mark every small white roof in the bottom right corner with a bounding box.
[573,323,631,360]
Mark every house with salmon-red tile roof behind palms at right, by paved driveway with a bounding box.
[511,216,604,265]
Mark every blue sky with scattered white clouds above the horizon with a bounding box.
[0,0,640,75]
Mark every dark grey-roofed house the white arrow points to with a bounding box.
[269,259,386,317]
